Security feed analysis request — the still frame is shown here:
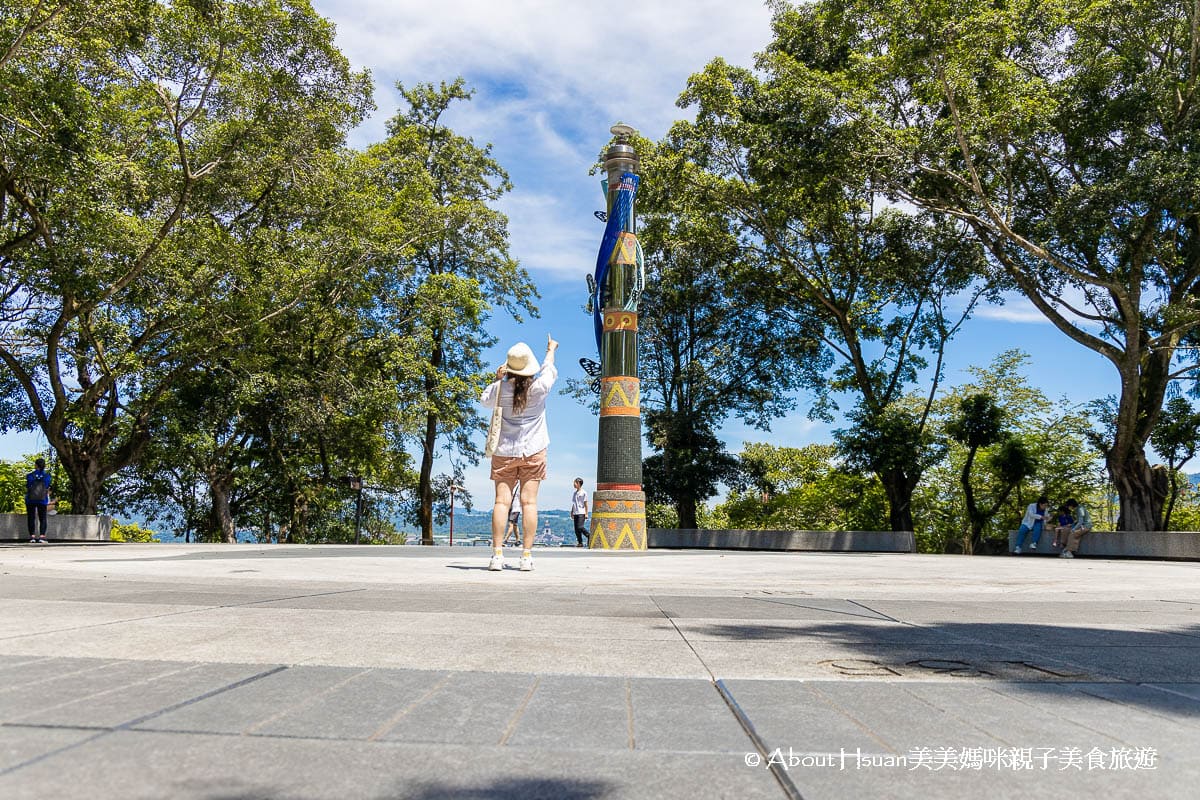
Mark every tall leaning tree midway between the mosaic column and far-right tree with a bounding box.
[671,49,986,530]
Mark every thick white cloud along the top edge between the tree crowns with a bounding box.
[316,0,770,136]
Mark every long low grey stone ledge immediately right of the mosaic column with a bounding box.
[647,528,917,553]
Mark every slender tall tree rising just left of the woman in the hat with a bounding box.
[370,78,538,545]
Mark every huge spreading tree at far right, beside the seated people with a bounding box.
[769,0,1200,530]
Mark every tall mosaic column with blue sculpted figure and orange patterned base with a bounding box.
[589,125,646,551]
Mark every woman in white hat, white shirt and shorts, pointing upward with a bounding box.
[479,336,558,572]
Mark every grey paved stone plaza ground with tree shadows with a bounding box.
[0,545,1200,800]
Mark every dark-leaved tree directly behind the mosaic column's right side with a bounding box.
[636,139,818,529]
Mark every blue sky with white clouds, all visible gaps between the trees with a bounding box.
[0,0,1117,509]
